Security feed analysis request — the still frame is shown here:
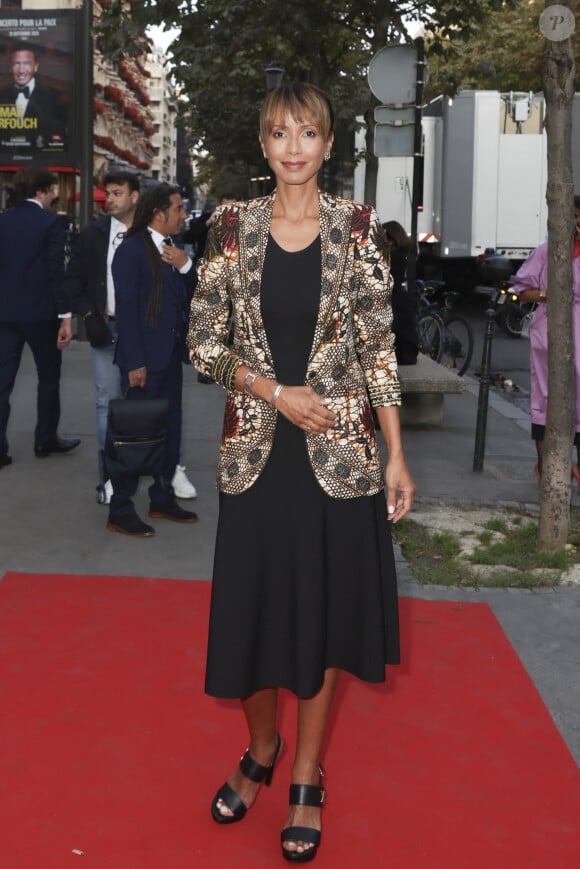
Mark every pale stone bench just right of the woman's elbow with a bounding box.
[399,353,465,425]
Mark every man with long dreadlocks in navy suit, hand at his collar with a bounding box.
[107,184,197,537]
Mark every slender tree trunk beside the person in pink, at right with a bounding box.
[539,0,576,552]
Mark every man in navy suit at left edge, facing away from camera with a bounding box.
[0,166,80,467]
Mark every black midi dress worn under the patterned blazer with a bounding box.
[206,237,399,698]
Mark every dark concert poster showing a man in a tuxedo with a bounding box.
[0,9,75,166]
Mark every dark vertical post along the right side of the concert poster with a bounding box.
[79,0,93,229]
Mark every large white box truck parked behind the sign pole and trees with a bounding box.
[355,91,580,289]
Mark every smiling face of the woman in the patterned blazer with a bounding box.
[260,115,334,185]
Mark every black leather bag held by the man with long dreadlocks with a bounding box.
[105,398,169,478]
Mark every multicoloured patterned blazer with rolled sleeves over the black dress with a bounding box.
[188,193,401,498]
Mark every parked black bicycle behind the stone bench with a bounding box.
[417,281,473,377]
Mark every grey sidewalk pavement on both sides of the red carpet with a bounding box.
[0,341,580,763]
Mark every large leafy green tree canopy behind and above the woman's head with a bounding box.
[97,0,516,202]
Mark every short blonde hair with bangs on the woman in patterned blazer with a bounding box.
[260,82,334,139]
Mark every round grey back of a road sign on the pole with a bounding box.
[368,45,417,105]
